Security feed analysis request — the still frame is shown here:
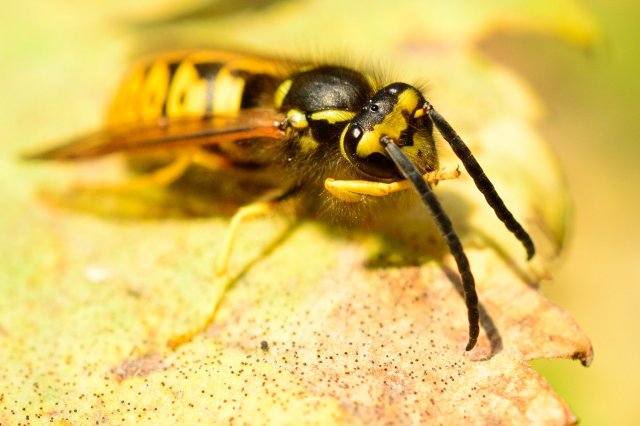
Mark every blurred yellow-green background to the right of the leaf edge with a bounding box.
[484,0,640,425]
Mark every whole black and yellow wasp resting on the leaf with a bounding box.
[29,51,535,351]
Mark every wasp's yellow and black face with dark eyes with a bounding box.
[340,83,437,180]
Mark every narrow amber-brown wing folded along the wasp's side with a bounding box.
[24,109,284,161]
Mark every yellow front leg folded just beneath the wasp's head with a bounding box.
[324,169,460,203]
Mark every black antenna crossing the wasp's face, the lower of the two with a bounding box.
[380,136,480,351]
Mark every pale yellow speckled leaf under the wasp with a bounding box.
[0,1,594,425]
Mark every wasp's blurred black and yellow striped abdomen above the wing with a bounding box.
[107,51,293,128]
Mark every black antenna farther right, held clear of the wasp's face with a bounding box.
[422,101,536,260]
